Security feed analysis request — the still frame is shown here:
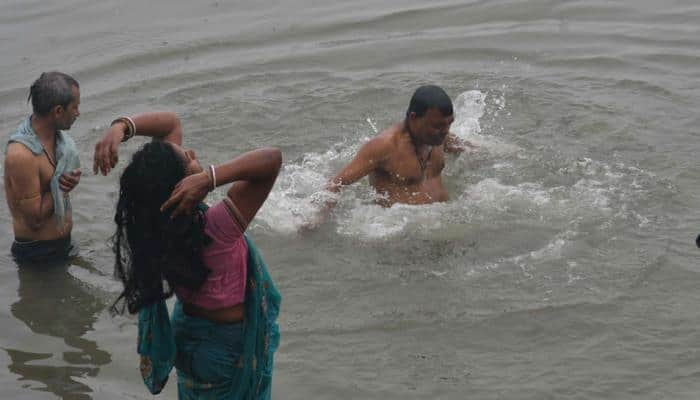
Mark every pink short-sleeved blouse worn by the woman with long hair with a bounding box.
[175,199,248,310]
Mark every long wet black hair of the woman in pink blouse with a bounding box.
[112,140,209,314]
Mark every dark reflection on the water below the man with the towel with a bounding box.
[5,259,111,399]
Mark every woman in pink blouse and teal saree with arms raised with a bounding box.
[93,112,282,399]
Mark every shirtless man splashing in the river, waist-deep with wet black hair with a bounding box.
[307,85,476,228]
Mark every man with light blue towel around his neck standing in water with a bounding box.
[4,72,80,263]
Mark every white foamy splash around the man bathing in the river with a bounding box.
[256,90,644,244]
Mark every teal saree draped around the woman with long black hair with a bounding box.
[138,235,281,400]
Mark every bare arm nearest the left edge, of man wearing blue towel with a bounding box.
[5,143,54,231]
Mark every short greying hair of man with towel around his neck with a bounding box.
[27,71,80,115]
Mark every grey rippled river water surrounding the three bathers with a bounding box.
[0,0,700,400]
